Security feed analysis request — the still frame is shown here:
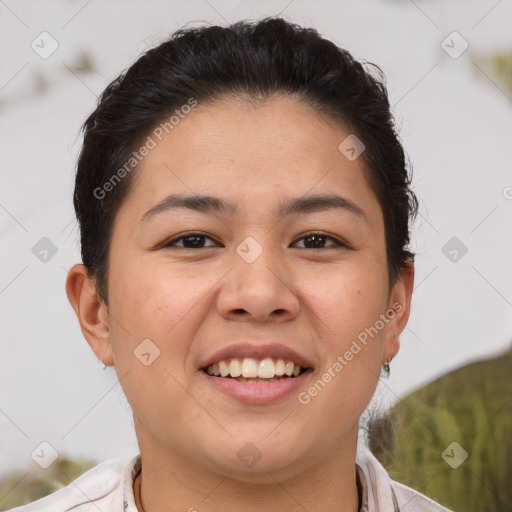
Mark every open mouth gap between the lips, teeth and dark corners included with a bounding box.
[203,357,312,383]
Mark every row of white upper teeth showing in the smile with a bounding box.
[206,357,300,379]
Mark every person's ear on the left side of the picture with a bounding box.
[66,264,114,366]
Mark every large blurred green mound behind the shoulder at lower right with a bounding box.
[370,350,512,512]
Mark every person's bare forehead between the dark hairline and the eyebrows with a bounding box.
[114,97,382,230]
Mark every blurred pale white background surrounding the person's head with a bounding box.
[0,0,512,472]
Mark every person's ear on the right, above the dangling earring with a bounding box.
[383,258,414,362]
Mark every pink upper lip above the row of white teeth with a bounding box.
[200,343,313,369]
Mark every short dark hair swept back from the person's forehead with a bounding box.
[74,18,418,304]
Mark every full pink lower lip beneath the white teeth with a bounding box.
[199,370,311,404]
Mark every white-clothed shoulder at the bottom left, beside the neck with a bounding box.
[6,459,133,512]
